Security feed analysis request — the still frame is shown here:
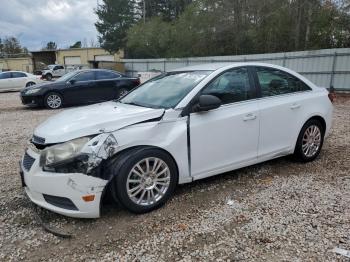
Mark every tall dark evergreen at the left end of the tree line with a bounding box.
[95,0,137,53]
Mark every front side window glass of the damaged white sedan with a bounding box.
[202,68,253,104]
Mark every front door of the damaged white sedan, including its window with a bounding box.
[190,67,260,179]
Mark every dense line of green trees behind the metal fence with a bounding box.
[95,0,350,58]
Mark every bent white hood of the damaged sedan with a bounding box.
[34,101,164,144]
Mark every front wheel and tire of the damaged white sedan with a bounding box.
[111,147,178,214]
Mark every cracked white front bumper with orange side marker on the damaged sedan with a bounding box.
[20,147,108,218]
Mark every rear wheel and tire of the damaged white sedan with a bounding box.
[294,119,325,162]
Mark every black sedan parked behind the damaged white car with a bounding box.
[21,69,140,109]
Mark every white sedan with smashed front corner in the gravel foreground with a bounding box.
[21,63,333,218]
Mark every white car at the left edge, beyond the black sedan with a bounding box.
[0,71,42,91]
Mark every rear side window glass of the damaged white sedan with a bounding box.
[256,67,311,97]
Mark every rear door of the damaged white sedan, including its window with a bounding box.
[255,67,311,158]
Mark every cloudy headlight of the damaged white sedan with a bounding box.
[40,137,91,167]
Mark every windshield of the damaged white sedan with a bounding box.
[120,71,212,109]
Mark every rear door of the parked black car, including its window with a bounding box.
[95,70,121,101]
